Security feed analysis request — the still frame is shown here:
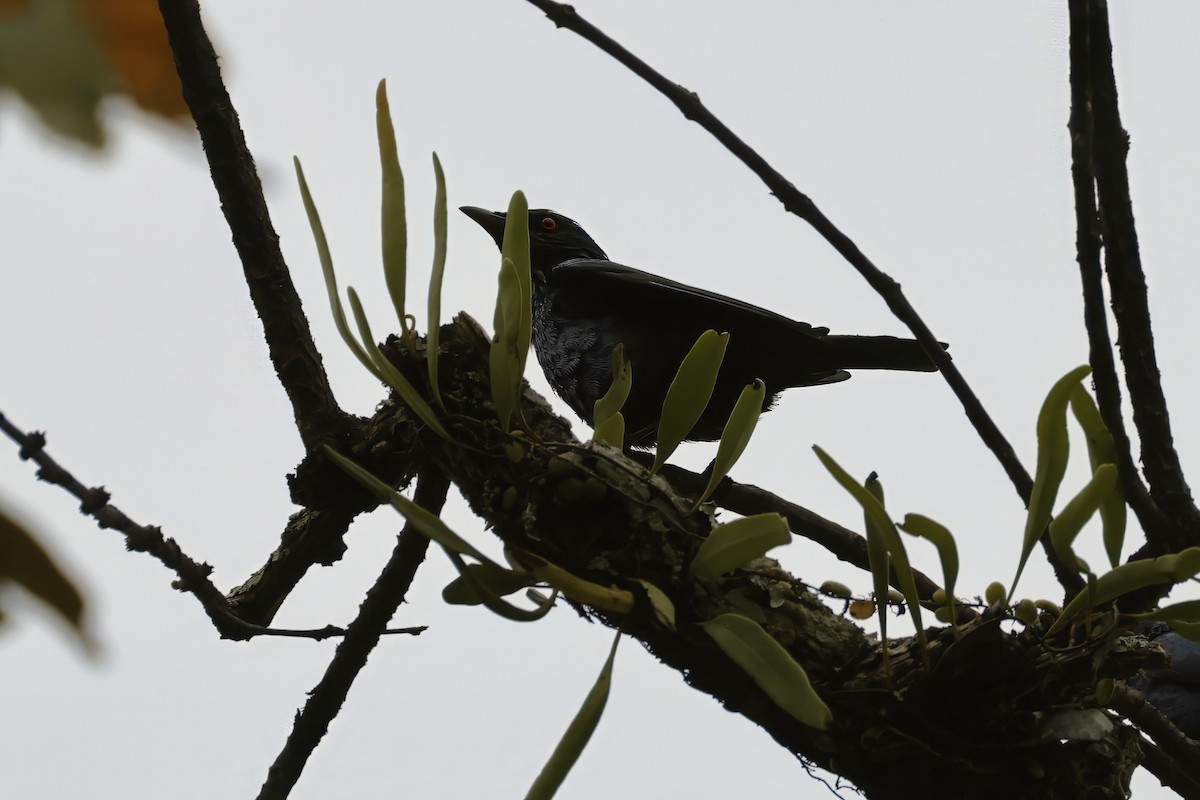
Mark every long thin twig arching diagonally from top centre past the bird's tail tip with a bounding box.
[528,0,1084,594]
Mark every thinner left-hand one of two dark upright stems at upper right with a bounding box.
[1067,0,1168,551]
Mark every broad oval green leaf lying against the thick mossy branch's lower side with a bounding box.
[700,614,833,730]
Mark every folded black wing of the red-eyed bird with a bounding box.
[552,258,829,338]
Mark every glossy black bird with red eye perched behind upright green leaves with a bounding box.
[460,205,946,450]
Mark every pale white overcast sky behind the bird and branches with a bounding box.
[0,0,1200,799]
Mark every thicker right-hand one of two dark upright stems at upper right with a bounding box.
[1070,0,1200,551]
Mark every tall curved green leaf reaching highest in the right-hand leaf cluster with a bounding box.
[1008,365,1092,601]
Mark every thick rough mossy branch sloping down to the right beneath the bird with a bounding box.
[263,315,1140,798]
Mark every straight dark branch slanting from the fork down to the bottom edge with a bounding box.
[258,470,450,800]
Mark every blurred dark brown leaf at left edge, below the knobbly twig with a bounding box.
[0,510,95,652]
